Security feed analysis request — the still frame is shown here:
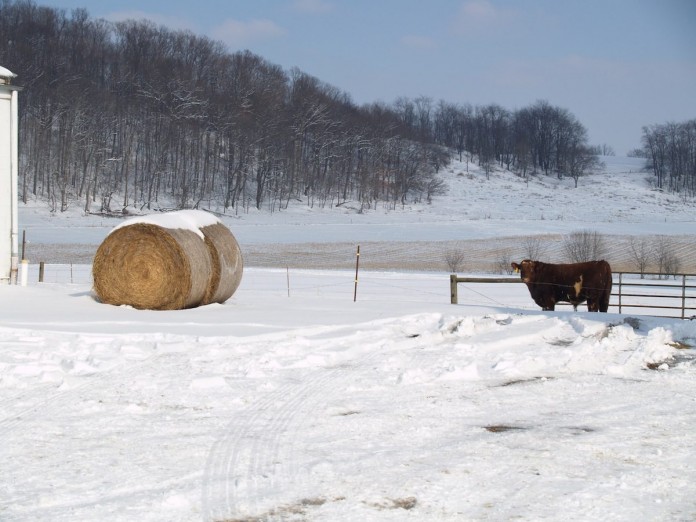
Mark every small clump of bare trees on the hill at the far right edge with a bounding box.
[643,120,696,197]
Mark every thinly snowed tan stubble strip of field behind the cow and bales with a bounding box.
[26,235,696,273]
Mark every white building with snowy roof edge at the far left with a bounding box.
[0,66,20,283]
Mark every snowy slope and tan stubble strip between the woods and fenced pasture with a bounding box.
[13,153,696,272]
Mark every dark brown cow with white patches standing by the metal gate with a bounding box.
[512,259,611,312]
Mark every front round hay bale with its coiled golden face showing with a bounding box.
[92,223,212,310]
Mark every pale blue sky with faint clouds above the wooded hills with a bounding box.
[36,0,696,154]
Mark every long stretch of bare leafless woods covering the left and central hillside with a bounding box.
[0,0,597,212]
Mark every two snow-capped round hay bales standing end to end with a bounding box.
[92,210,243,310]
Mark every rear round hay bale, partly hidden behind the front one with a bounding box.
[201,223,244,304]
